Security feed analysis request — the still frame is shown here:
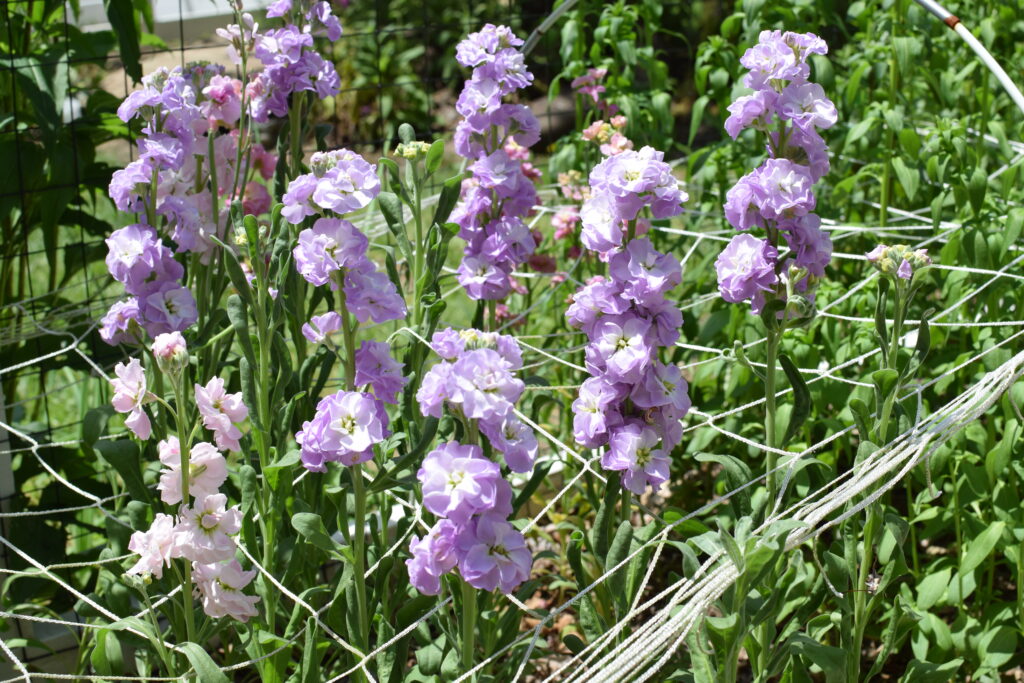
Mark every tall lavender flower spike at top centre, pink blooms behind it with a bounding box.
[452,24,541,299]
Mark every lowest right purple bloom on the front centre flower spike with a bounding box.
[456,515,534,593]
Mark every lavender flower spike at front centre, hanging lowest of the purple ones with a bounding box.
[406,328,538,595]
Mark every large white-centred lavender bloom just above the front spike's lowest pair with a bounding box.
[416,441,512,524]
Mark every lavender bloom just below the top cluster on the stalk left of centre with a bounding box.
[292,218,370,286]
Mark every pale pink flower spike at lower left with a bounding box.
[121,337,259,622]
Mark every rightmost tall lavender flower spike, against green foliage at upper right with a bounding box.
[715,31,837,312]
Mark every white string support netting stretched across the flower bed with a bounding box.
[0,142,1024,683]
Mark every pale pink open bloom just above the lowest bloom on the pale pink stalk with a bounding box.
[176,494,242,563]
